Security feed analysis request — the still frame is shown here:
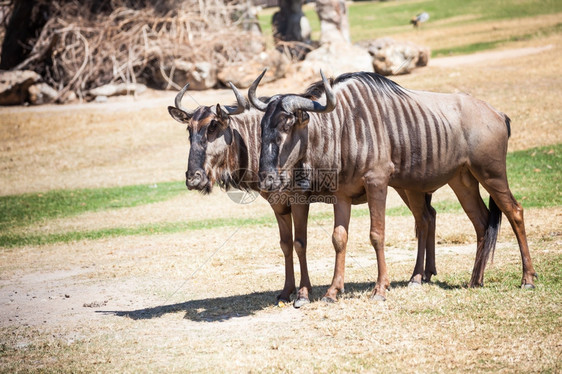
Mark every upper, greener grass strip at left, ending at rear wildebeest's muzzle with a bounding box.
[0,182,185,231]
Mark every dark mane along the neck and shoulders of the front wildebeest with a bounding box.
[302,72,407,100]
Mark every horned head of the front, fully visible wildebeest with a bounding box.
[248,70,336,191]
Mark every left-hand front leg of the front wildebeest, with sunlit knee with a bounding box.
[322,196,351,302]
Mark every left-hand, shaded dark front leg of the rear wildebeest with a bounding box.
[274,209,295,303]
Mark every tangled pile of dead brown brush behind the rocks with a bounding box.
[8,0,262,102]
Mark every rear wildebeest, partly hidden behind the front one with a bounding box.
[168,80,436,307]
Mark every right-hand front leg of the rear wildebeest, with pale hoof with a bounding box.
[291,204,312,308]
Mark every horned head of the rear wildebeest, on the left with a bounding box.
[168,83,248,193]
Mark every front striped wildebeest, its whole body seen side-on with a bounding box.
[249,71,536,300]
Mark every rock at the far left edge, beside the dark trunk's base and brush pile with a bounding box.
[0,70,41,105]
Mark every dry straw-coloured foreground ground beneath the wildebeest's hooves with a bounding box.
[0,208,562,372]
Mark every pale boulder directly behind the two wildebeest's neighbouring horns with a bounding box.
[218,50,290,88]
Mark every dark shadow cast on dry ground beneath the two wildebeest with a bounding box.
[96,281,461,322]
